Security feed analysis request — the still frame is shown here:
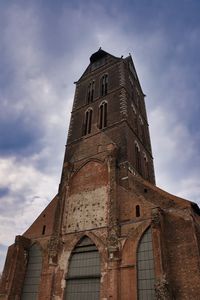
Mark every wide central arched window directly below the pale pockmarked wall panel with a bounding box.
[65,237,101,300]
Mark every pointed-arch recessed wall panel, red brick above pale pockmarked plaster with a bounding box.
[63,161,108,233]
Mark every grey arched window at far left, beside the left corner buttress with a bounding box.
[21,244,42,300]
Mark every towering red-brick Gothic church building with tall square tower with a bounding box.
[0,49,200,300]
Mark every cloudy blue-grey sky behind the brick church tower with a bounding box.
[0,0,200,270]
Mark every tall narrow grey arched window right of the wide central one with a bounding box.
[137,228,155,300]
